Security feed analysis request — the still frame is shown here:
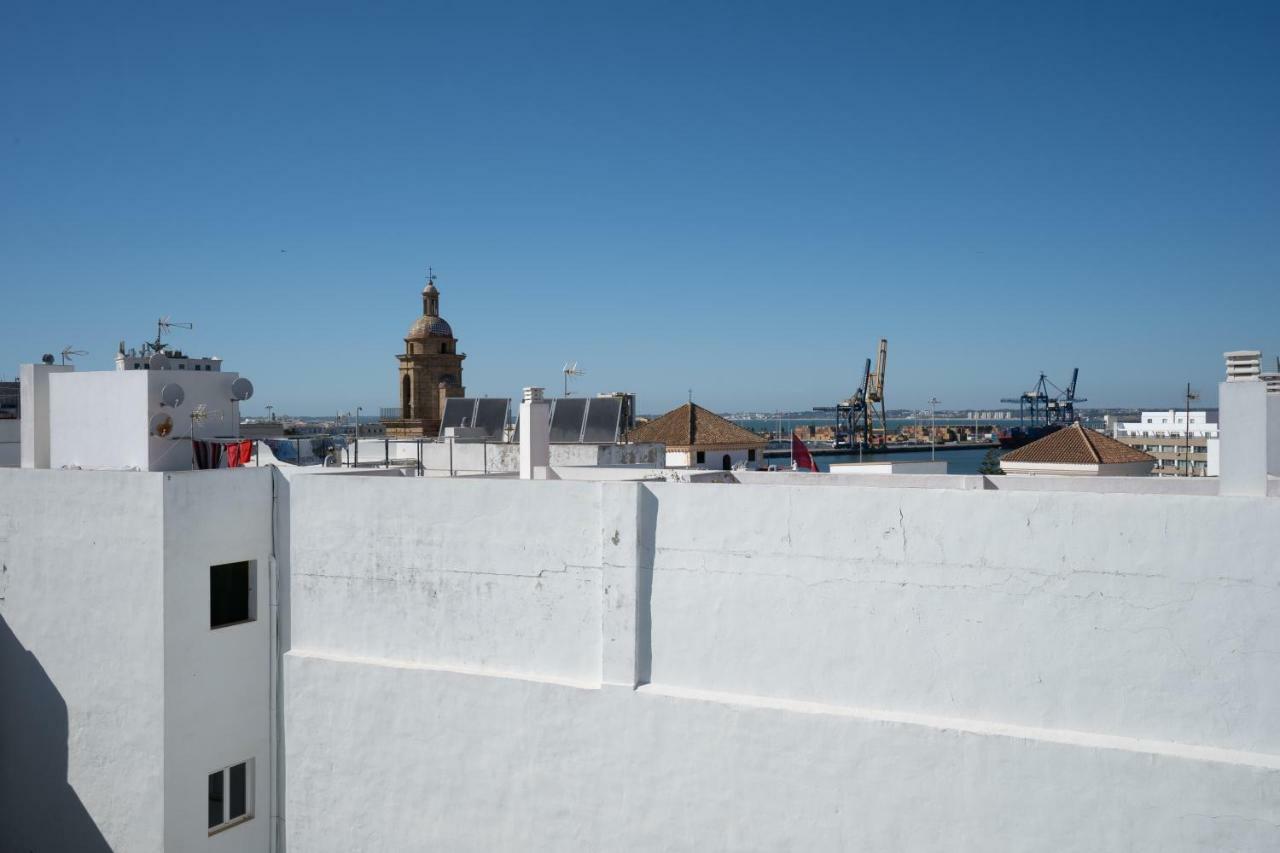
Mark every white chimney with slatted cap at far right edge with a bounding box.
[1217,350,1280,496]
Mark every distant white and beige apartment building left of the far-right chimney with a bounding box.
[1106,409,1219,476]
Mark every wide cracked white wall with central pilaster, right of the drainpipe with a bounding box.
[284,475,1280,853]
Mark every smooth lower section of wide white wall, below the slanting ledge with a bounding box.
[285,654,1280,853]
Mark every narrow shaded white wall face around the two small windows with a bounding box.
[164,468,274,852]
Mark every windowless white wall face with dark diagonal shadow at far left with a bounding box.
[0,469,165,853]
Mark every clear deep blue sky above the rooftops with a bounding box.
[0,1,1280,414]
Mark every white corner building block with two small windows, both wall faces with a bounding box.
[0,466,276,853]
